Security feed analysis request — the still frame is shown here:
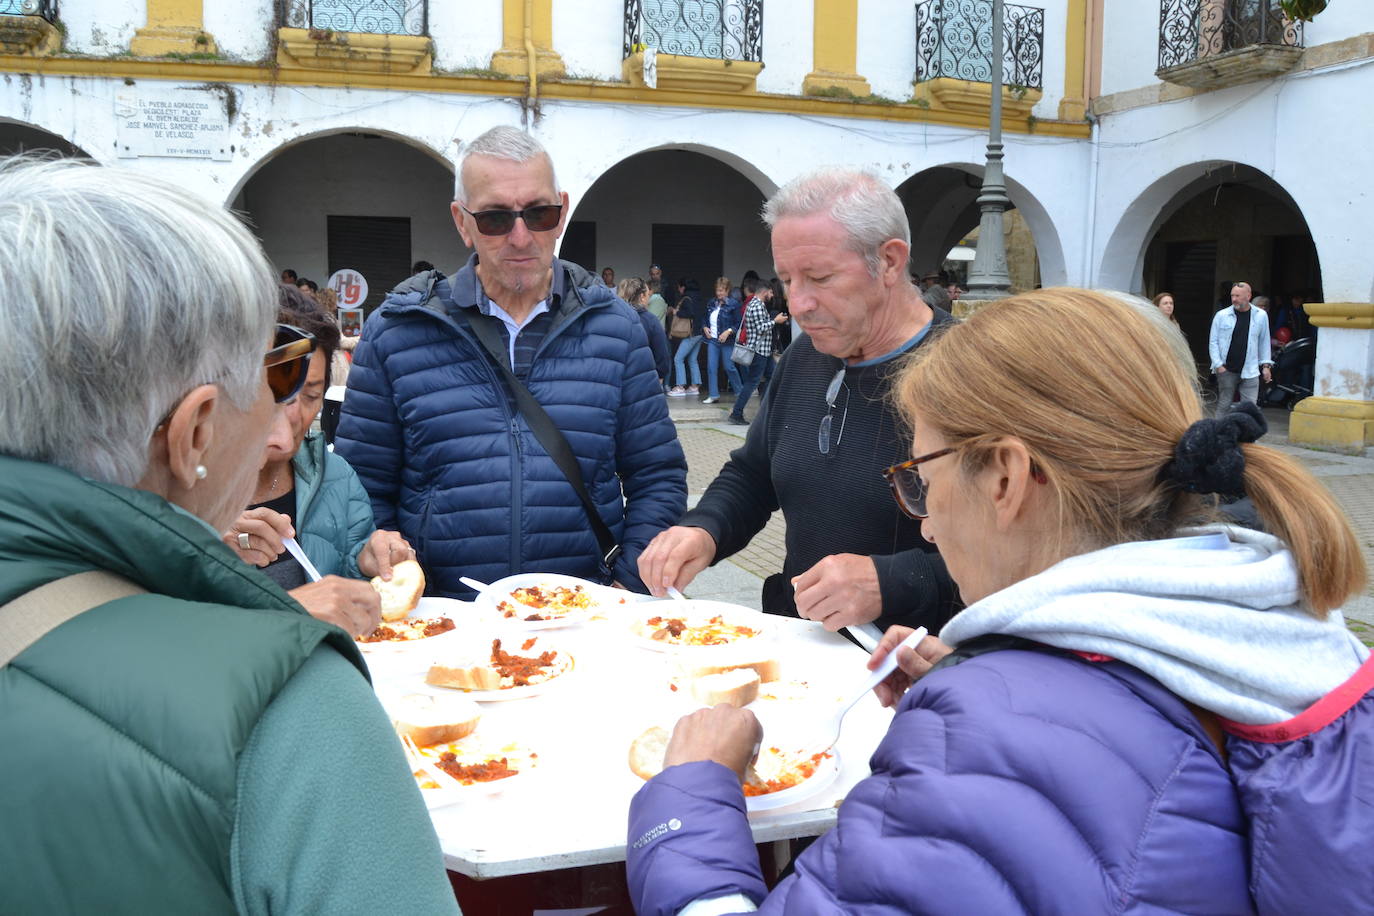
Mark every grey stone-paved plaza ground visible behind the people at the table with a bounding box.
[668,394,1374,644]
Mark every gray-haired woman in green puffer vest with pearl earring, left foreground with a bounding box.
[0,159,456,913]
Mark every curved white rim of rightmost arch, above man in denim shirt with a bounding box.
[1094,159,1323,293]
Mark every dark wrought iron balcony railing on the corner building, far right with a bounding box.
[1160,0,1303,70]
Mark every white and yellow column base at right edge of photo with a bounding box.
[1289,302,1374,452]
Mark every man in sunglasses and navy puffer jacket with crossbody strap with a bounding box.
[337,128,687,597]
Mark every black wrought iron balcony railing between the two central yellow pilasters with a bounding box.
[624,0,764,60]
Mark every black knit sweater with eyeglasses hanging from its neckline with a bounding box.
[679,309,959,633]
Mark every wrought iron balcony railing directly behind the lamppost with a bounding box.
[916,0,1044,89]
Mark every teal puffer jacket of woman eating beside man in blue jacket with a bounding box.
[291,433,376,578]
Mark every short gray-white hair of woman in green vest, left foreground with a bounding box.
[0,157,278,486]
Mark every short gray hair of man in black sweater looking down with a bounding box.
[763,166,911,276]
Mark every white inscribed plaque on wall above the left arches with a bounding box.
[114,88,229,161]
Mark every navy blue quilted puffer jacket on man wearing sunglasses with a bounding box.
[335,257,687,597]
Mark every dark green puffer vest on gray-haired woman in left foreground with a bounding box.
[0,457,395,913]
